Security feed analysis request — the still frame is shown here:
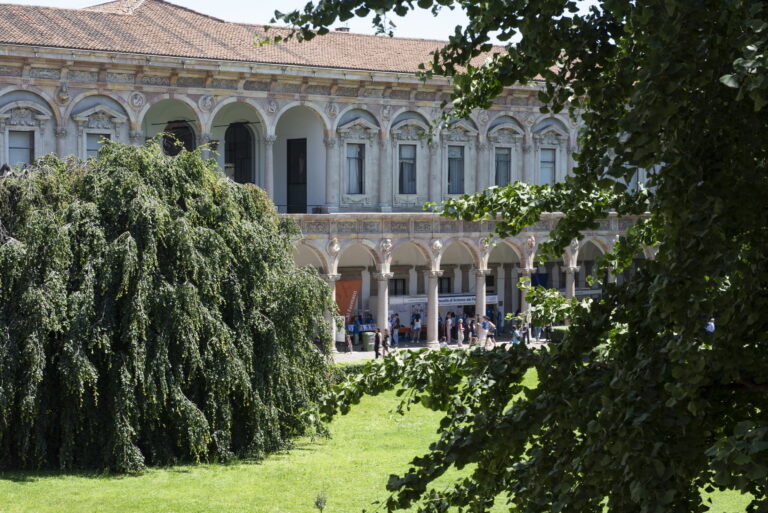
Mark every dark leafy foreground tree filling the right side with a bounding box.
[270,0,768,512]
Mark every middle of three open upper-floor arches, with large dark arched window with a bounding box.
[211,102,263,185]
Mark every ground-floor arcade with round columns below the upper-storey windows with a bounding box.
[287,209,643,346]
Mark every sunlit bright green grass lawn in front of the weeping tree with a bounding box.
[0,370,746,513]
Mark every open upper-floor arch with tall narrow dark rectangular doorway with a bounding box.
[274,105,326,214]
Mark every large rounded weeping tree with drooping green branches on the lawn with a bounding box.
[0,140,333,471]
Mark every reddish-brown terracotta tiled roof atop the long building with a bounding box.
[0,0,474,73]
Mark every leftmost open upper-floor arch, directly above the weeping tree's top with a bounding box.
[141,99,199,156]
